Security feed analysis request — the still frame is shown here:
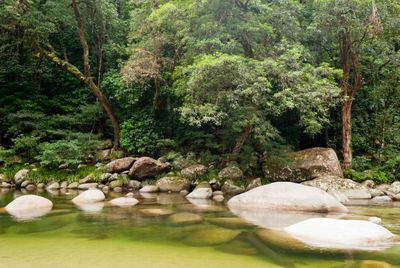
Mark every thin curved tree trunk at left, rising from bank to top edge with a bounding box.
[71,0,120,149]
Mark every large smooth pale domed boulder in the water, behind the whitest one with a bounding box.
[228,182,348,212]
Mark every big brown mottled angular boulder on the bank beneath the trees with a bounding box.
[263,148,343,182]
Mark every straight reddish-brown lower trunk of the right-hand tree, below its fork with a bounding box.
[342,99,353,169]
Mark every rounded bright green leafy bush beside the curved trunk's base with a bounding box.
[121,114,161,155]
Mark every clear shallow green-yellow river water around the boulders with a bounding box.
[0,188,400,268]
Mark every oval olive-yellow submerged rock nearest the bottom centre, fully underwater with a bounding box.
[184,227,240,246]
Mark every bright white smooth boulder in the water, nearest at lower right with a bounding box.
[284,218,395,250]
